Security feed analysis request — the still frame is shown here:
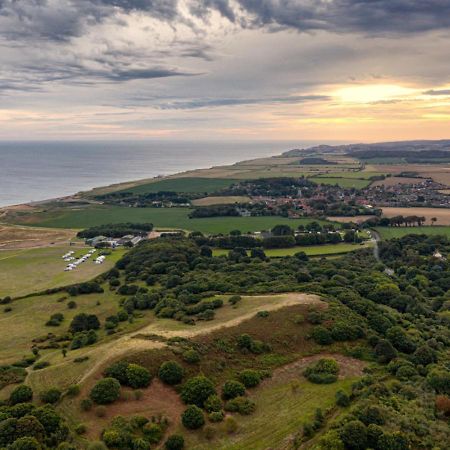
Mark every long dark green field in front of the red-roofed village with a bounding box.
[12,206,334,233]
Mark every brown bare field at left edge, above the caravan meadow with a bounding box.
[0,225,76,250]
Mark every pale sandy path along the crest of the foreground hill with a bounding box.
[79,292,326,383]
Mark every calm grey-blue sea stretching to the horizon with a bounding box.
[0,141,330,206]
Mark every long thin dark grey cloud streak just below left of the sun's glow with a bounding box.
[158,95,330,109]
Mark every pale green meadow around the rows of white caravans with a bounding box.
[0,245,125,297]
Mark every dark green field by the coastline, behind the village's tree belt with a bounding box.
[119,178,236,194]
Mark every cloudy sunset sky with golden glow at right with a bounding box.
[0,0,450,142]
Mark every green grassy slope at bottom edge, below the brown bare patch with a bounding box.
[185,374,356,450]
